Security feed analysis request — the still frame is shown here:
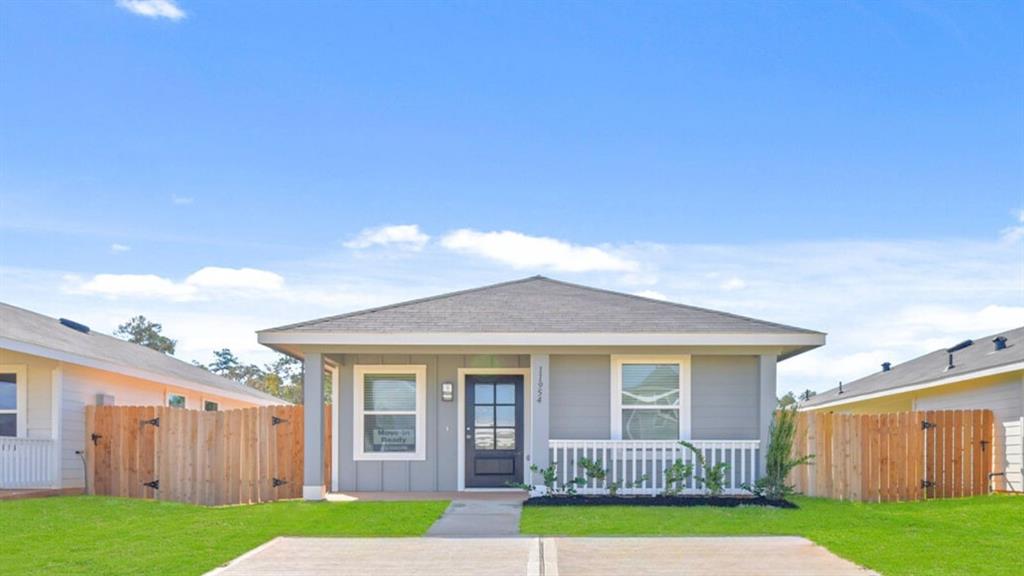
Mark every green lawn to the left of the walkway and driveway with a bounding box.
[0,496,447,575]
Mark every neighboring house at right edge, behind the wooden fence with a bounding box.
[800,327,1024,492]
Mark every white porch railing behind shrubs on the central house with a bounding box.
[552,440,761,495]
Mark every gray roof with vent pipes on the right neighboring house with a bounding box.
[800,326,1024,409]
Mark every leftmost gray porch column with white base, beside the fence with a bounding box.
[302,353,324,500]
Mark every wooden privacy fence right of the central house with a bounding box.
[790,410,997,502]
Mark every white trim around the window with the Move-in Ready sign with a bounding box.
[352,364,427,461]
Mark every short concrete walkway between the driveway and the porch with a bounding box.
[427,496,522,538]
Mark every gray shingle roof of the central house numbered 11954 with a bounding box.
[261,276,820,334]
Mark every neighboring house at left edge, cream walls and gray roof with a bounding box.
[0,302,285,491]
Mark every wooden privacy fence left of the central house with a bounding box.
[85,406,331,505]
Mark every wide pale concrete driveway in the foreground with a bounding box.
[210,536,874,576]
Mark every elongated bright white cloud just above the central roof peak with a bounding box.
[441,229,639,273]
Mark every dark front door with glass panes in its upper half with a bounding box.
[465,375,523,488]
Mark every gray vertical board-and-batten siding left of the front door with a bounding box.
[329,354,529,492]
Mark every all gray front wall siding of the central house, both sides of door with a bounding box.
[330,355,760,492]
